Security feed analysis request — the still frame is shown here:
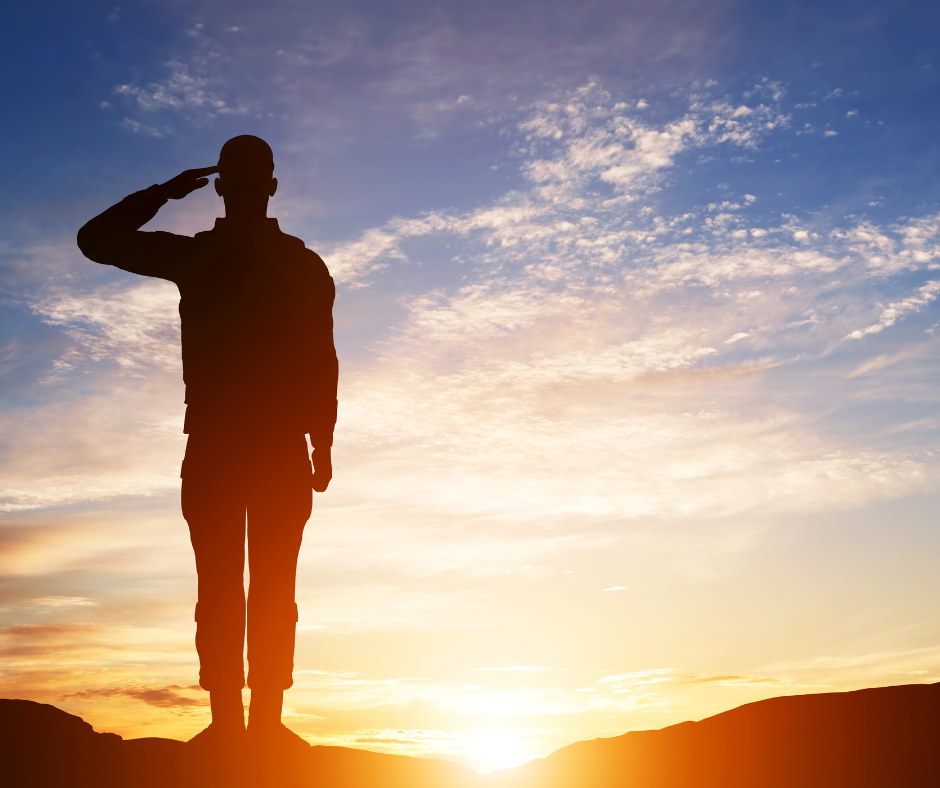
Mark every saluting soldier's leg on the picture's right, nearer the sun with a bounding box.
[248,435,312,723]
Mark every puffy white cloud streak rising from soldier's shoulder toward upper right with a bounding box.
[327,84,788,282]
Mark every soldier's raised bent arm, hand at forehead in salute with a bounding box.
[78,167,218,281]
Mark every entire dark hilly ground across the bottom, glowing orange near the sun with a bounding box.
[0,684,940,788]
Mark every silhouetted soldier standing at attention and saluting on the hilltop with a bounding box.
[78,135,337,747]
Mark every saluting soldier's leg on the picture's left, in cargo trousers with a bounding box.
[182,436,246,708]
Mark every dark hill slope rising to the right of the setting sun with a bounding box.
[489,684,940,788]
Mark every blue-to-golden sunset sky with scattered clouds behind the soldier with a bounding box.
[0,0,940,771]
